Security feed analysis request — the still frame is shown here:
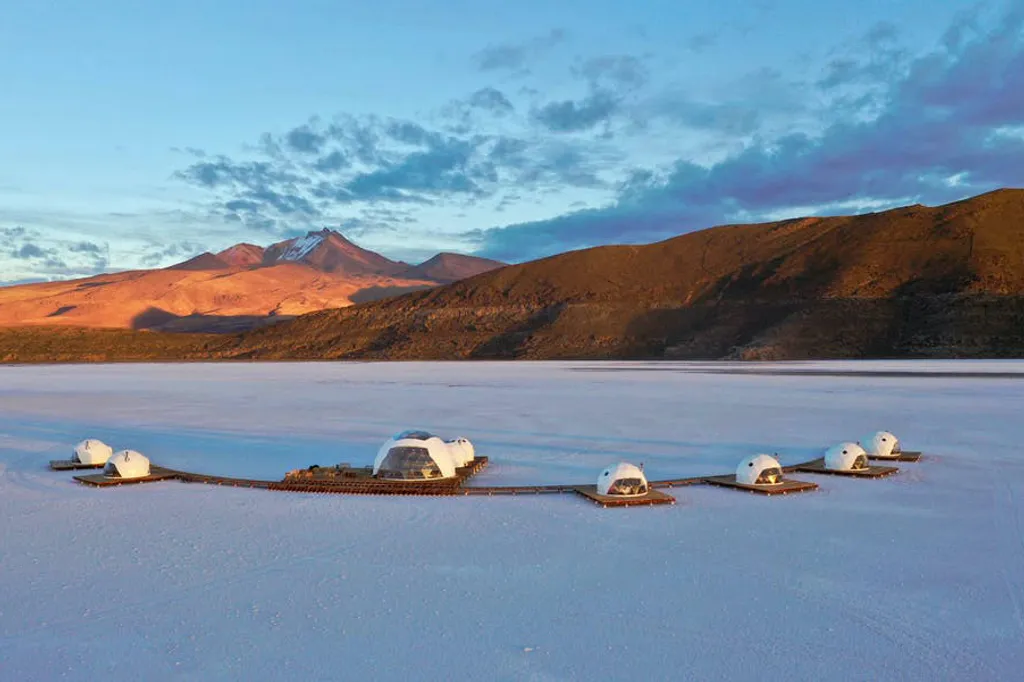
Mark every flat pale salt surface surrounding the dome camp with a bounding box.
[0,363,1024,680]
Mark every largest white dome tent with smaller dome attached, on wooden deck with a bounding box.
[373,431,475,480]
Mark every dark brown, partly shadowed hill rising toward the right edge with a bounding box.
[230,189,1024,358]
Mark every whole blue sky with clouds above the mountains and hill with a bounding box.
[0,0,1024,283]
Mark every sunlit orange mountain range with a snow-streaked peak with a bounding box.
[0,229,504,332]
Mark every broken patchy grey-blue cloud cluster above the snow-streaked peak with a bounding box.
[175,96,626,236]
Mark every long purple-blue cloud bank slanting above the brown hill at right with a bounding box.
[469,8,1024,259]
